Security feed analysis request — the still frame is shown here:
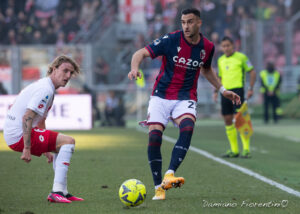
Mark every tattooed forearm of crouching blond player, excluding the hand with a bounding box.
[22,109,36,149]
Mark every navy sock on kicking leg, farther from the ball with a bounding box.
[169,118,195,172]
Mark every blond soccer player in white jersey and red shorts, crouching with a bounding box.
[3,56,83,203]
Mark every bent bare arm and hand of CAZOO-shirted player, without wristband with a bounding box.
[128,48,150,80]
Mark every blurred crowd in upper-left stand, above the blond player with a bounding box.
[0,0,102,45]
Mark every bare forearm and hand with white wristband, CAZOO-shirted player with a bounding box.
[202,66,241,104]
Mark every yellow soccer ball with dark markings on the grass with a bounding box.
[119,179,146,207]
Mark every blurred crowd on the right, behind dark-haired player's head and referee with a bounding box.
[141,0,300,67]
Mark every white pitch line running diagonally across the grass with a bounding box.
[138,128,300,198]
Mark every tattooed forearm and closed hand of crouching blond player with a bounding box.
[21,109,36,163]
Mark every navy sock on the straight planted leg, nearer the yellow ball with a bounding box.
[148,130,162,186]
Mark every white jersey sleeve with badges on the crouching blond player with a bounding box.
[27,90,53,117]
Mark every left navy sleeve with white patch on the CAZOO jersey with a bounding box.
[145,34,171,59]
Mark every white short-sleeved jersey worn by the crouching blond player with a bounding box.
[3,77,55,145]
